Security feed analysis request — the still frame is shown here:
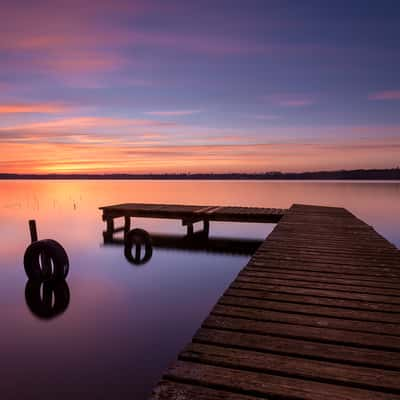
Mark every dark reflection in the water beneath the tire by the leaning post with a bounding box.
[25,279,70,319]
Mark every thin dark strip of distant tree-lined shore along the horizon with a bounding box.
[0,168,400,180]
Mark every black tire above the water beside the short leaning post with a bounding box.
[24,239,69,281]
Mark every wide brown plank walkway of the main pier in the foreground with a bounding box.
[151,205,400,400]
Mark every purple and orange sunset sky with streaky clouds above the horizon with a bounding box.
[0,0,400,173]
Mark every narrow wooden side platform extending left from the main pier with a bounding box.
[100,203,286,224]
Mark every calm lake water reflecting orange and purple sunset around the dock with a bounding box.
[0,181,400,400]
